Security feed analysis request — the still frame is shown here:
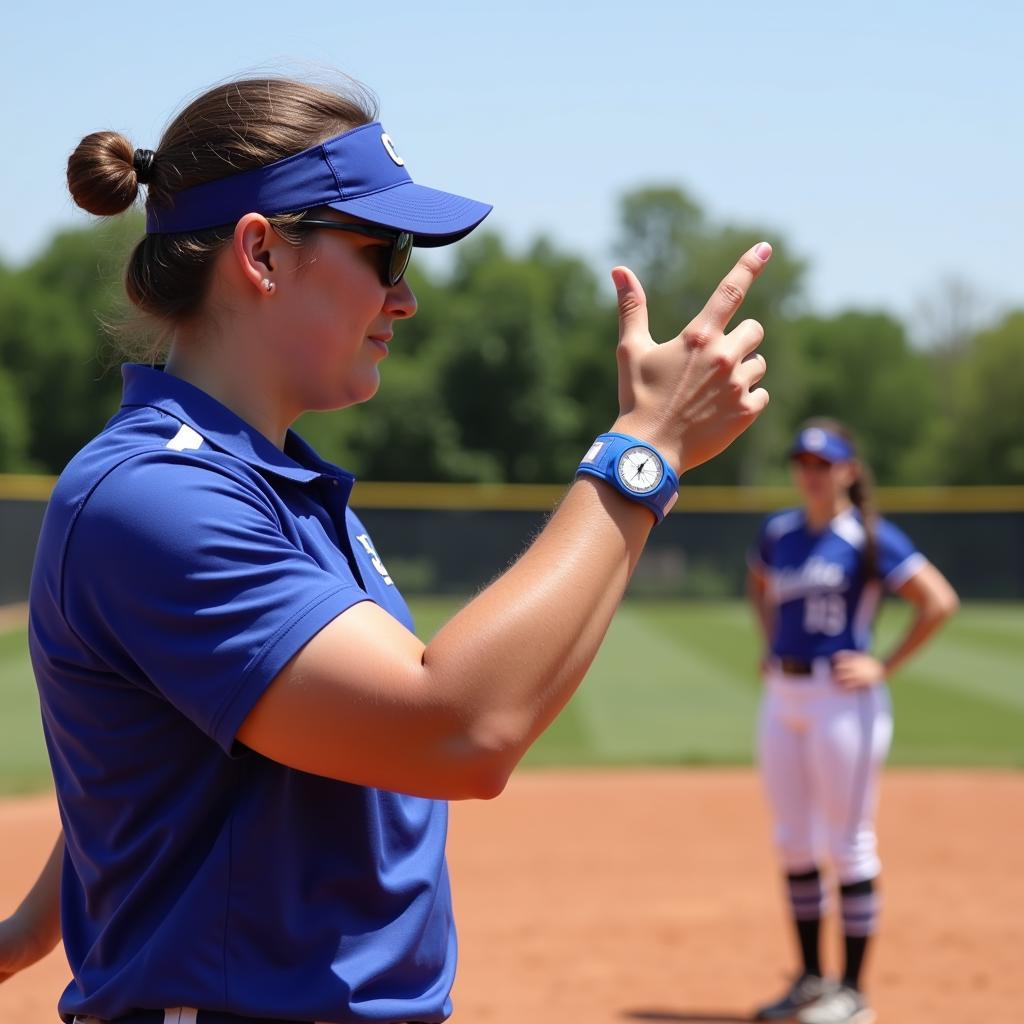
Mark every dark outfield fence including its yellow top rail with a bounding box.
[0,475,1024,603]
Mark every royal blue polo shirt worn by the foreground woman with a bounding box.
[30,366,456,1022]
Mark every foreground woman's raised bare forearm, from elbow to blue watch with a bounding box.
[423,479,653,760]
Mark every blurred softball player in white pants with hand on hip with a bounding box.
[749,419,957,1024]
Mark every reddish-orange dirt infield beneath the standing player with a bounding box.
[0,771,1024,1024]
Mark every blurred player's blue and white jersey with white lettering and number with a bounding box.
[752,509,925,660]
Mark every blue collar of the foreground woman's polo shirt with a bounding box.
[121,362,355,487]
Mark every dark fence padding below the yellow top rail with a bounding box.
[0,499,1024,602]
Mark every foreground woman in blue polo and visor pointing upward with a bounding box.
[0,74,771,1024]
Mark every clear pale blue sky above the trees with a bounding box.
[0,0,1024,319]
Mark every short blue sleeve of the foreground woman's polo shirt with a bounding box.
[60,453,367,753]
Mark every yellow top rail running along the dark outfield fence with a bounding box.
[0,473,1024,512]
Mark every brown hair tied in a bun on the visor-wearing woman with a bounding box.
[68,78,377,352]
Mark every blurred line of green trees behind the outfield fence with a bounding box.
[0,186,1024,484]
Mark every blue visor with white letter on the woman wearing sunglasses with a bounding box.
[145,121,492,246]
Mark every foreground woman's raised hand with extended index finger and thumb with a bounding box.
[611,242,771,473]
